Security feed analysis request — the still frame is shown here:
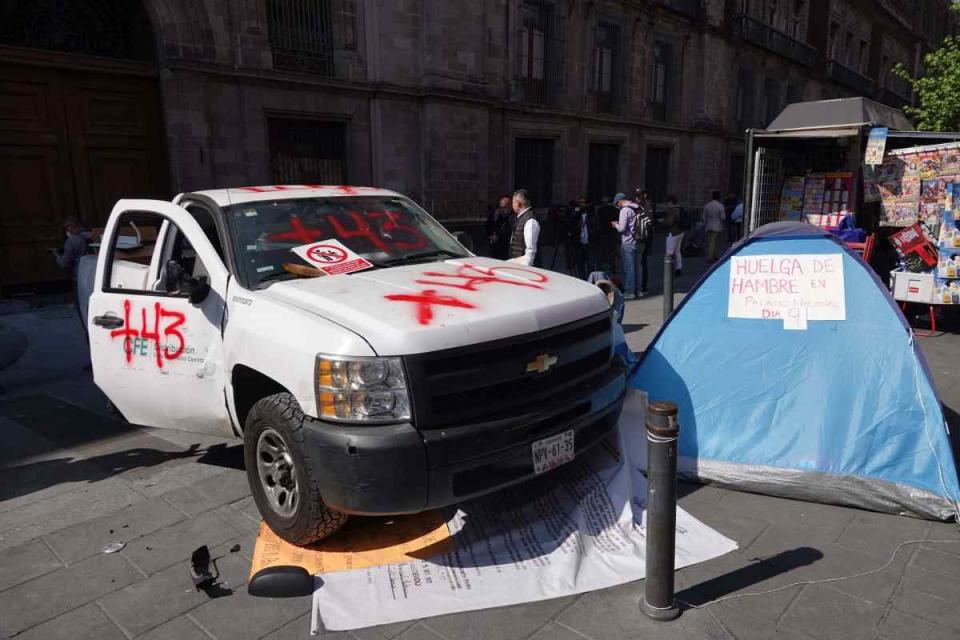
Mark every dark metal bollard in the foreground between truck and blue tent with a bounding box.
[640,402,680,620]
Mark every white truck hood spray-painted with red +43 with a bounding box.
[261,257,610,355]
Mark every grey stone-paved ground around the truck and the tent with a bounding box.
[0,252,960,640]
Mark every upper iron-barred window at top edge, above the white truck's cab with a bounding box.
[266,0,334,76]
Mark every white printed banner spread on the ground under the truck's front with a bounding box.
[312,392,737,633]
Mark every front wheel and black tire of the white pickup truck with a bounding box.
[243,393,347,546]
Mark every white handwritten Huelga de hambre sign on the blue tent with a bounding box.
[727,254,847,330]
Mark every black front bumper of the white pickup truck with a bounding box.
[303,359,626,515]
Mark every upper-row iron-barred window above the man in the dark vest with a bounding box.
[514,0,564,104]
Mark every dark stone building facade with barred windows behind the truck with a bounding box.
[0,0,956,283]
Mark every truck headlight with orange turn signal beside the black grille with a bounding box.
[317,355,410,422]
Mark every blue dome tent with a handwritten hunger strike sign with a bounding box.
[632,222,960,519]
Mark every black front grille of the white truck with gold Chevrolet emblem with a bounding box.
[406,313,613,429]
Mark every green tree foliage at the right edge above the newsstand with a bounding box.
[893,36,960,131]
